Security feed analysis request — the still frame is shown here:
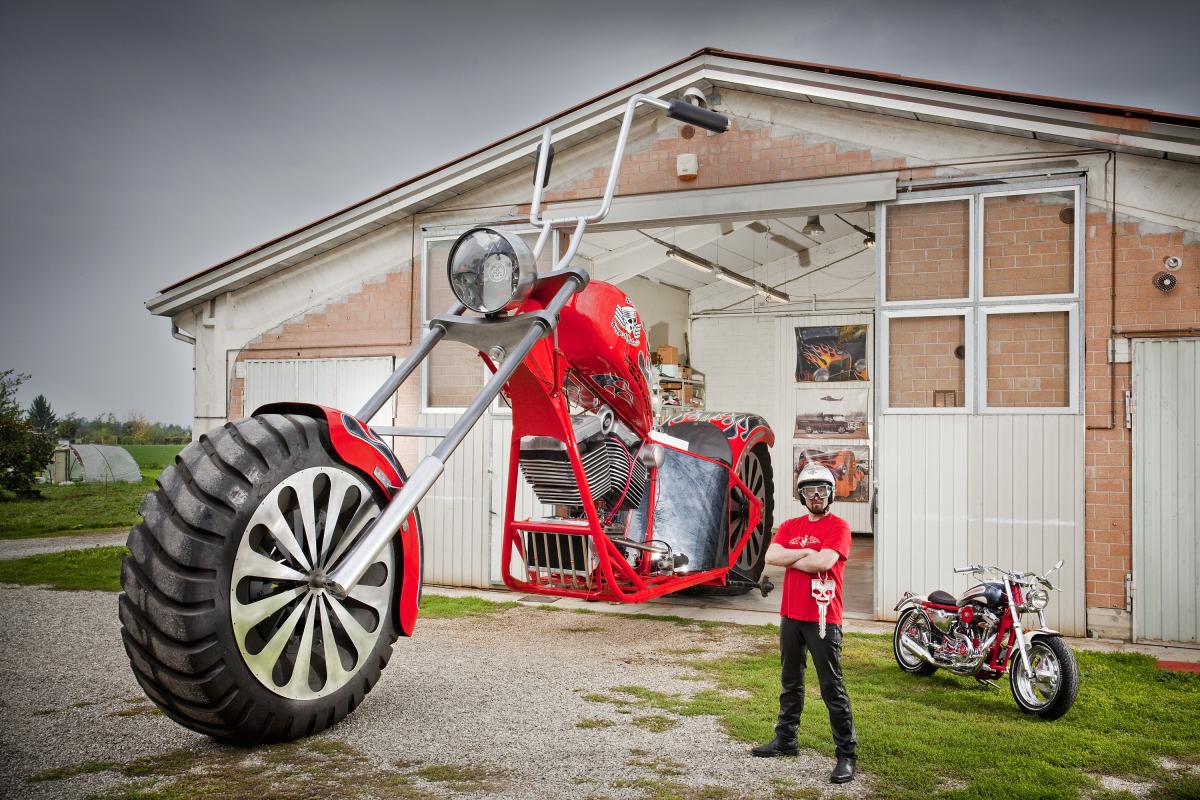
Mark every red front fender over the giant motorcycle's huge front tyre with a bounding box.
[254,403,425,636]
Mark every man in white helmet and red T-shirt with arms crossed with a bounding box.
[751,462,858,783]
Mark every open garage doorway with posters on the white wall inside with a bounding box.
[566,208,877,618]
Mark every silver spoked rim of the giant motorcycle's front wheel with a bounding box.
[229,467,395,699]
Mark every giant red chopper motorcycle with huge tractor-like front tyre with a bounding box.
[120,95,774,742]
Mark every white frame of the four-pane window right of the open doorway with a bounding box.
[876,176,1087,414]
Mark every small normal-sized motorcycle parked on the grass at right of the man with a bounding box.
[892,560,1079,720]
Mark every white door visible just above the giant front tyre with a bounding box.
[245,357,396,426]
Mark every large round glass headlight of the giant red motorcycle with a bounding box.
[446,228,538,314]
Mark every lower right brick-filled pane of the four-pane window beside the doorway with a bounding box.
[988,311,1070,408]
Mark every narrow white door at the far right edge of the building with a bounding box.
[1133,339,1200,642]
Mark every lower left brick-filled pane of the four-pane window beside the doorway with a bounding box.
[888,315,966,408]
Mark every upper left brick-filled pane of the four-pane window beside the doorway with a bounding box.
[886,200,971,301]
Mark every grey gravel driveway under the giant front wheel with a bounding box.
[0,588,868,800]
